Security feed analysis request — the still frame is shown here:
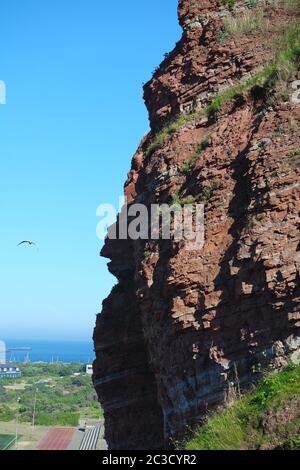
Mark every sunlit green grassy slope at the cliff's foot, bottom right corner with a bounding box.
[184,365,300,450]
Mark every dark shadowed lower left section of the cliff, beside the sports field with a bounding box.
[94,284,164,450]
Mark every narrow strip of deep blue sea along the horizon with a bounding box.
[5,339,95,364]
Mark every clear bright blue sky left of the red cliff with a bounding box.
[0,0,181,339]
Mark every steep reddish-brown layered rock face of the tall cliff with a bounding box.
[94,0,300,449]
